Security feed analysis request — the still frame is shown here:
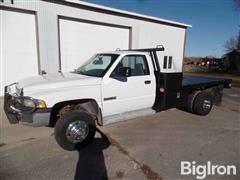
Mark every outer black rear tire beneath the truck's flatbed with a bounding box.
[193,92,213,116]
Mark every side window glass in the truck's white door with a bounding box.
[112,55,149,76]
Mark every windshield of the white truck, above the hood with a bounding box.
[75,54,119,77]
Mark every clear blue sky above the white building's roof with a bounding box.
[88,0,240,57]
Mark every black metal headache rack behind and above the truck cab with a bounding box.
[116,45,165,71]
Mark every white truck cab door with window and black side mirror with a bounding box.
[102,55,156,116]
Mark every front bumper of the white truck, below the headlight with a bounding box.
[4,88,51,126]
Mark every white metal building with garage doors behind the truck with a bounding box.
[0,0,190,95]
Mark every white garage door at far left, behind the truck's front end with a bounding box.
[0,10,38,95]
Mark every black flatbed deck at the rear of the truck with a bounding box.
[182,75,232,89]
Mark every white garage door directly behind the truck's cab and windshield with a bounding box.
[59,19,129,72]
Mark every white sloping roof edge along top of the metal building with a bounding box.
[50,0,192,28]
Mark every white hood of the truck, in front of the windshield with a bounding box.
[18,73,102,93]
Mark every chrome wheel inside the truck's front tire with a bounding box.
[66,120,89,143]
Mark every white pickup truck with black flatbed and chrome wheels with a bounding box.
[4,47,231,150]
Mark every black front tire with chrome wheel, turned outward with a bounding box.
[54,111,96,151]
